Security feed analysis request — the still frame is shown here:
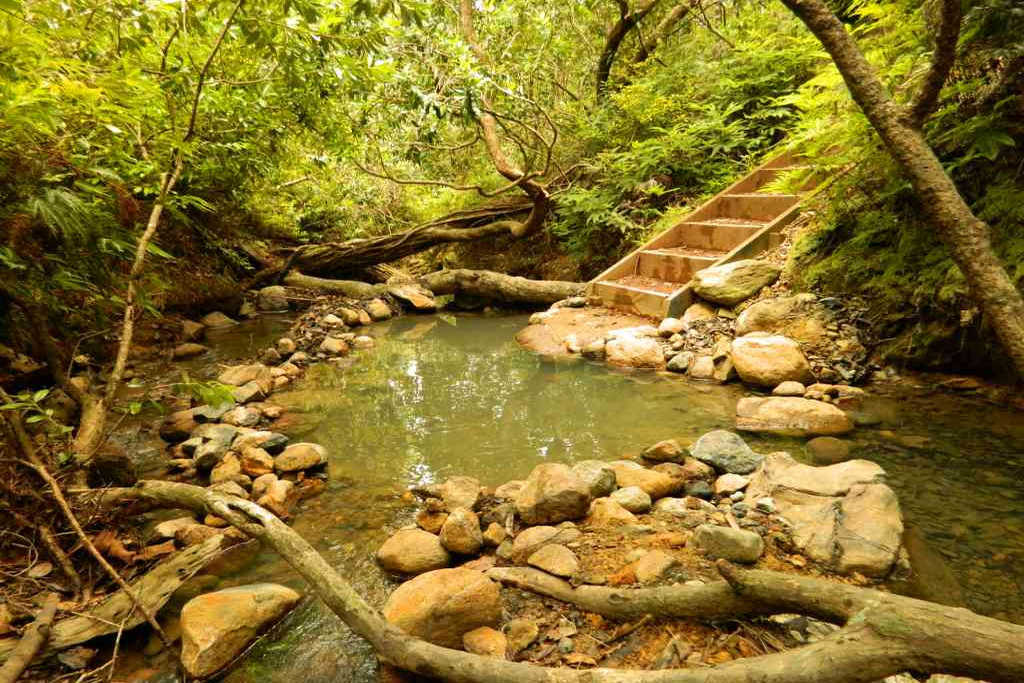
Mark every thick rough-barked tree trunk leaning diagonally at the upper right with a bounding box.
[782,0,1024,378]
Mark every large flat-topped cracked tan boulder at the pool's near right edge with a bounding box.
[746,453,903,577]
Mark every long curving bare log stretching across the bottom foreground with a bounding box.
[101,481,1024,683]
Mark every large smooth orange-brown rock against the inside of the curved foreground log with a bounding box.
[384,568,502,647]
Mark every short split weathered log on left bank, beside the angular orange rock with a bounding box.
[0,535,224,661]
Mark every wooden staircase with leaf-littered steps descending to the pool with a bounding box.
[587,153,818,317]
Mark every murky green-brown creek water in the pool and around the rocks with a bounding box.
[130,315,1024,683]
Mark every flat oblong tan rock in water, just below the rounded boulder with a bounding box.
[736,396,853,436]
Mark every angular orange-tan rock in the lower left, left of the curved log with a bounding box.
[181,584,301,678]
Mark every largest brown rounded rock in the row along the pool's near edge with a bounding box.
[515,463,590,524]
